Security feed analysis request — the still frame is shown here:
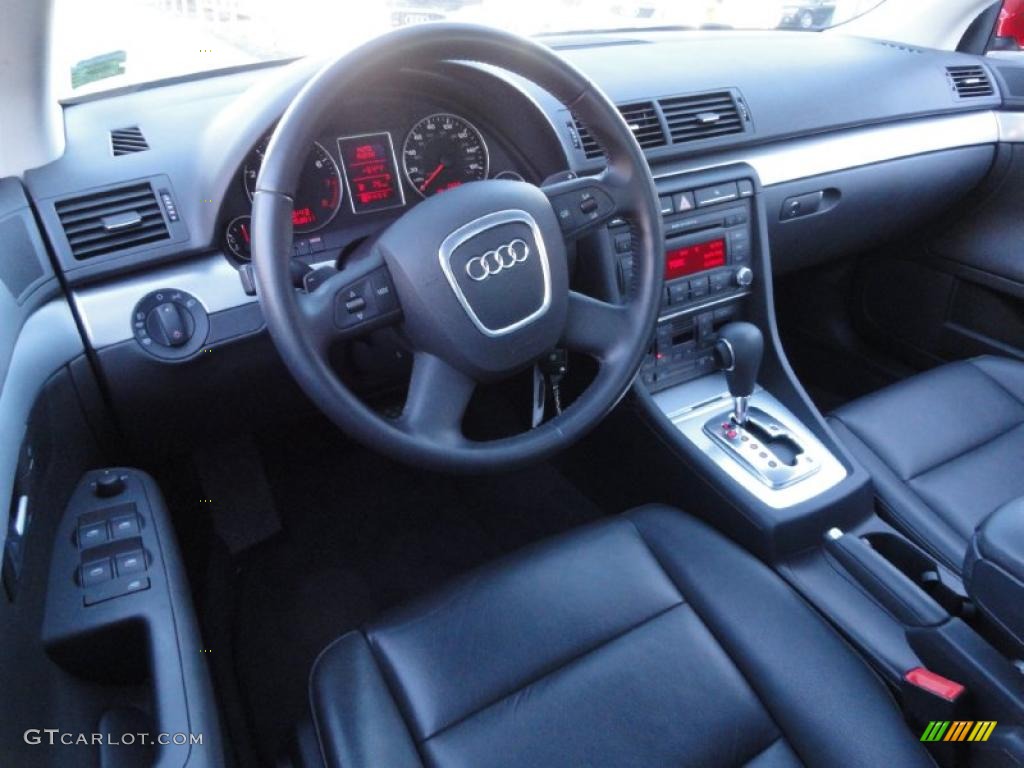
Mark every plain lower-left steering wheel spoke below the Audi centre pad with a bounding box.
[398,351,476,443]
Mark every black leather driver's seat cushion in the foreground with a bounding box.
[310,507,932,768]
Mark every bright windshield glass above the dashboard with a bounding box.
[51,0,882,97]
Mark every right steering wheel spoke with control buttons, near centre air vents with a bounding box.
[541,169,634,241]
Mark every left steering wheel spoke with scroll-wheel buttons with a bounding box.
[299,260,401,350]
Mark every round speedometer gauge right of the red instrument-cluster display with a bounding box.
[401,113,490,198]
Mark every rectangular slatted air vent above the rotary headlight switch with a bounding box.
[54,183,170,260]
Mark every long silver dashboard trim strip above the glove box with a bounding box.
[654,111,999,186]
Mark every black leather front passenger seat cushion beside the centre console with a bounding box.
[831,356,1024,572]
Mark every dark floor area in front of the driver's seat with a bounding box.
[224,421,610,764]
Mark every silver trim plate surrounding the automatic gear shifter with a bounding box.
[652,373,847,509]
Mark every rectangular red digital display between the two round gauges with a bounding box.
[338,132,406,213]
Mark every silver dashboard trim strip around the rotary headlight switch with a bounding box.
[72,253,256,349]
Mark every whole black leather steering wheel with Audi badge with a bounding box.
[252,24,664,472]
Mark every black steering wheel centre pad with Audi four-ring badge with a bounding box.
[377,180,568,381]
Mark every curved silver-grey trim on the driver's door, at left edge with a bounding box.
[0,299,83,552]
